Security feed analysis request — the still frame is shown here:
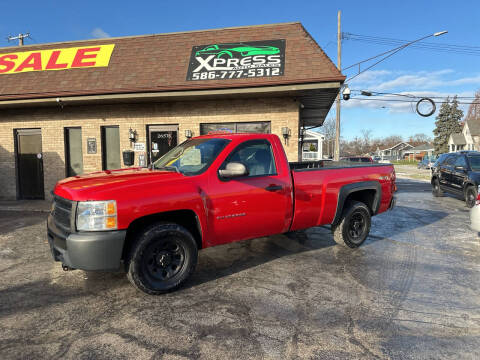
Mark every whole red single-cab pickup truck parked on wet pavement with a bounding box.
[47,134,396,294]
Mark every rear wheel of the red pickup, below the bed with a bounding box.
[332,201,372,248]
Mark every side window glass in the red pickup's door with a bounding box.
[221,140,277,176]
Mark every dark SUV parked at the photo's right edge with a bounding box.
[431,151,480,208]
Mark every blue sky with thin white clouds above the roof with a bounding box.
[0,0,480,139]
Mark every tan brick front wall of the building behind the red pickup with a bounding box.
[0,98,299,200]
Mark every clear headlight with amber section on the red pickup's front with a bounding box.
[77,200,117,231]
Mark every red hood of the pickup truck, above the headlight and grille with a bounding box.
[54,168,185,201]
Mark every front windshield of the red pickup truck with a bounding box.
[152,139,228,175]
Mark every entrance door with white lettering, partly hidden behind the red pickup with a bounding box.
[147,125,178,163]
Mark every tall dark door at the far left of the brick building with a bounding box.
[15,129,45,199]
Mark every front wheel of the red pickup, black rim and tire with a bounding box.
[126,223,198,295]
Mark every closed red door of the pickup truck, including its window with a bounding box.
[207,139,293,244]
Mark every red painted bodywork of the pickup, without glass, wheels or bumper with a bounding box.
[54,134,394,247]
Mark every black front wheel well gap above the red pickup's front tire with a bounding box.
[122,210,202,259]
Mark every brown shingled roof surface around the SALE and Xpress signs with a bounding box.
[0,23,345,100]
